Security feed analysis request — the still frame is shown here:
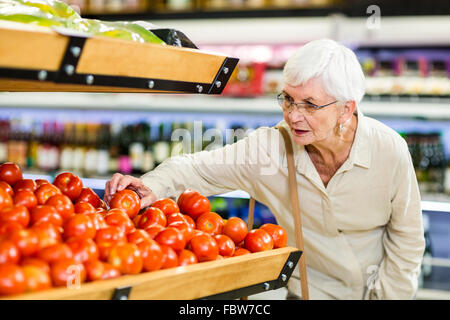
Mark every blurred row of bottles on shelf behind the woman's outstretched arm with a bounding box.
[0,119,255,177]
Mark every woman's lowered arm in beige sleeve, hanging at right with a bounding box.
[368,143,425,299]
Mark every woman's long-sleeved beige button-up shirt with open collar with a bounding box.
[142,110,425,299]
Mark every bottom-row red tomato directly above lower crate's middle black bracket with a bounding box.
[108,243,143,274]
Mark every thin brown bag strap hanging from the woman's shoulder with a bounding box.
[247,126,309,300]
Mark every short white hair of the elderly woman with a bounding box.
[283,39,365,105]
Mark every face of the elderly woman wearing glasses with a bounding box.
[283,79,339,145]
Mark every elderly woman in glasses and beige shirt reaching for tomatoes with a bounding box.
[105,39,424,299]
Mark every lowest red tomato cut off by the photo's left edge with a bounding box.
[0,263,27,295]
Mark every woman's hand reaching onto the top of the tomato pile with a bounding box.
[104,173,156,209]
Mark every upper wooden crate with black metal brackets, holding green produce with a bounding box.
[0,20,238,94]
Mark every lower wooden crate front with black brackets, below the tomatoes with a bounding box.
[2,247,302,300]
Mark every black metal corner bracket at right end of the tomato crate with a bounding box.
[200,250,302,300]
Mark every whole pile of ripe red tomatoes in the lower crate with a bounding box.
[0,163,287,295]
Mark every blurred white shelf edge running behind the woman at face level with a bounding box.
[0,92,450,120]
